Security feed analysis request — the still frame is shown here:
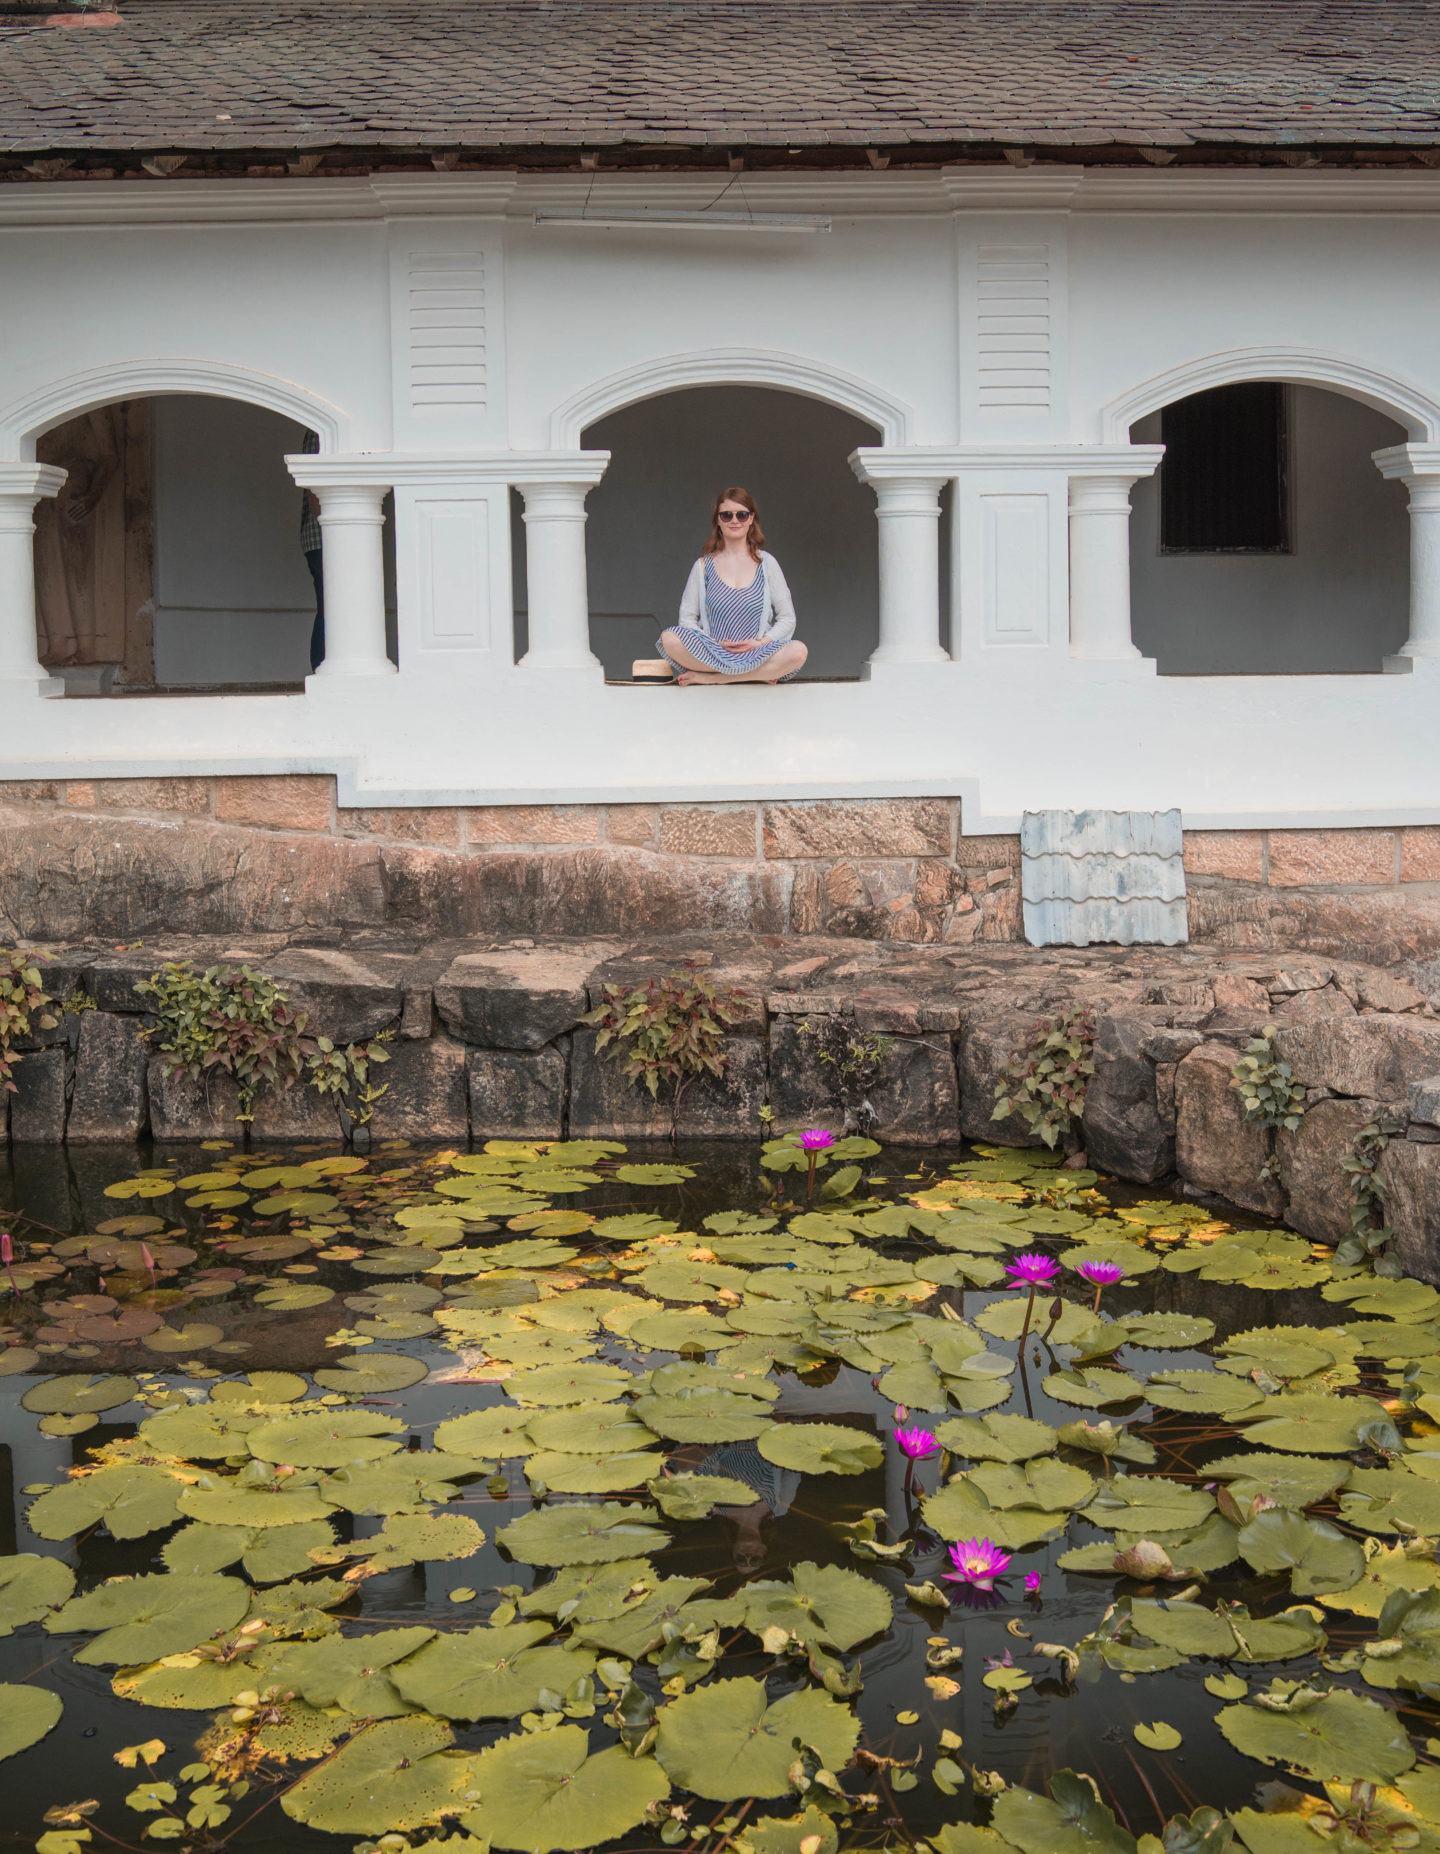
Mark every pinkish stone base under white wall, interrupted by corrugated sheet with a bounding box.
[0,773,1440,983]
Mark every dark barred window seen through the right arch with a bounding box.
[1160,380,1292,554]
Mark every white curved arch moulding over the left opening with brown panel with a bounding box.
[0,360,348,464]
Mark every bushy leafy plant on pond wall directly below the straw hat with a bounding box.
[580,960,747,1138]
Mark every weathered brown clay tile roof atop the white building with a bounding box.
[0,0,1440,154]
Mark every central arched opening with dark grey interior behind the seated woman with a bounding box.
[582,386,880,680]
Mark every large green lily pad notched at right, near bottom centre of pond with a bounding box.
[654,1680,860,1802]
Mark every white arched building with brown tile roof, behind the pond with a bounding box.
[0,0,1440,834]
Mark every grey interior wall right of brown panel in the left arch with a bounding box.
[150,393,315,686]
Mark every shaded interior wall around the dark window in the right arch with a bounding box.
[1131,386,1410,675]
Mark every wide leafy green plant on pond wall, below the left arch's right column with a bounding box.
[135,960,391,1125]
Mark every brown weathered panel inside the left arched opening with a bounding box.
[35,400,154,684]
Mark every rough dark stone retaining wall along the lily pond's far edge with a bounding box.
[7,933,1440,1279]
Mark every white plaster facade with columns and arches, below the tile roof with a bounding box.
[0,174,1440,829]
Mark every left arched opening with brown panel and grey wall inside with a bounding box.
[35,393,395,695]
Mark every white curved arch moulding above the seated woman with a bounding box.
[550,349,914,451]
